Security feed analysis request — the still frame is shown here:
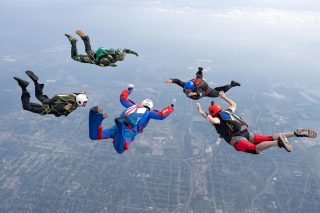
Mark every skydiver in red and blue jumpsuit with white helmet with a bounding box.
[89,84,175,154]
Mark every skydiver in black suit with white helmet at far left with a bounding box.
[13,70,88,117]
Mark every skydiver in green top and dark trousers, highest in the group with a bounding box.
[65,30,138,67]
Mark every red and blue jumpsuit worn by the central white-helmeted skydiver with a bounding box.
[89,89,174,154]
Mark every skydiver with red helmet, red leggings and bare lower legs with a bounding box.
[197,91,317,154]
